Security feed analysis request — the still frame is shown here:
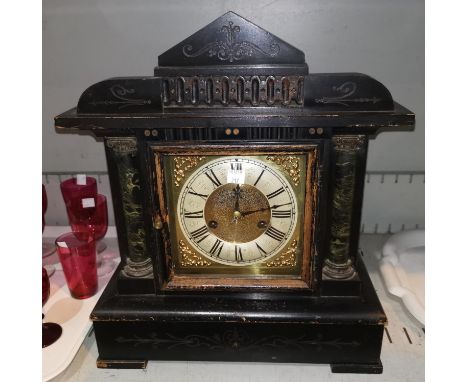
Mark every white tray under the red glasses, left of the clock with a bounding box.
[42,227,120,382]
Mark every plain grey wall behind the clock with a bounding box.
[42,0,424,231]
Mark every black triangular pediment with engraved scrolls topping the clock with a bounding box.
[158,12,305,67]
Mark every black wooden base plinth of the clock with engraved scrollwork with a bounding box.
[91,256,386,373]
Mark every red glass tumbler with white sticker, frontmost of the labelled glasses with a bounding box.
[55,232,98,299]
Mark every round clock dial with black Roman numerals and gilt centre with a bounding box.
[177,156,297,266]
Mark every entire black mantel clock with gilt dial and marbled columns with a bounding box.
[56,12,414,373]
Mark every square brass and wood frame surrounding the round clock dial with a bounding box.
[151,144,318,289]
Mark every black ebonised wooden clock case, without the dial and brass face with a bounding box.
[56,12,414,373]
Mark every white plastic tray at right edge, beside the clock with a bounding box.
[380,230,425,325]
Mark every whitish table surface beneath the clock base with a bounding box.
[46,235,425,382]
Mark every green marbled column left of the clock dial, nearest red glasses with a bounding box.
[106,137,153,277]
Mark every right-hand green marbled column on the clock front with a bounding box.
[323,135,365,280]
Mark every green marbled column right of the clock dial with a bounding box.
[322,135,367,280]
